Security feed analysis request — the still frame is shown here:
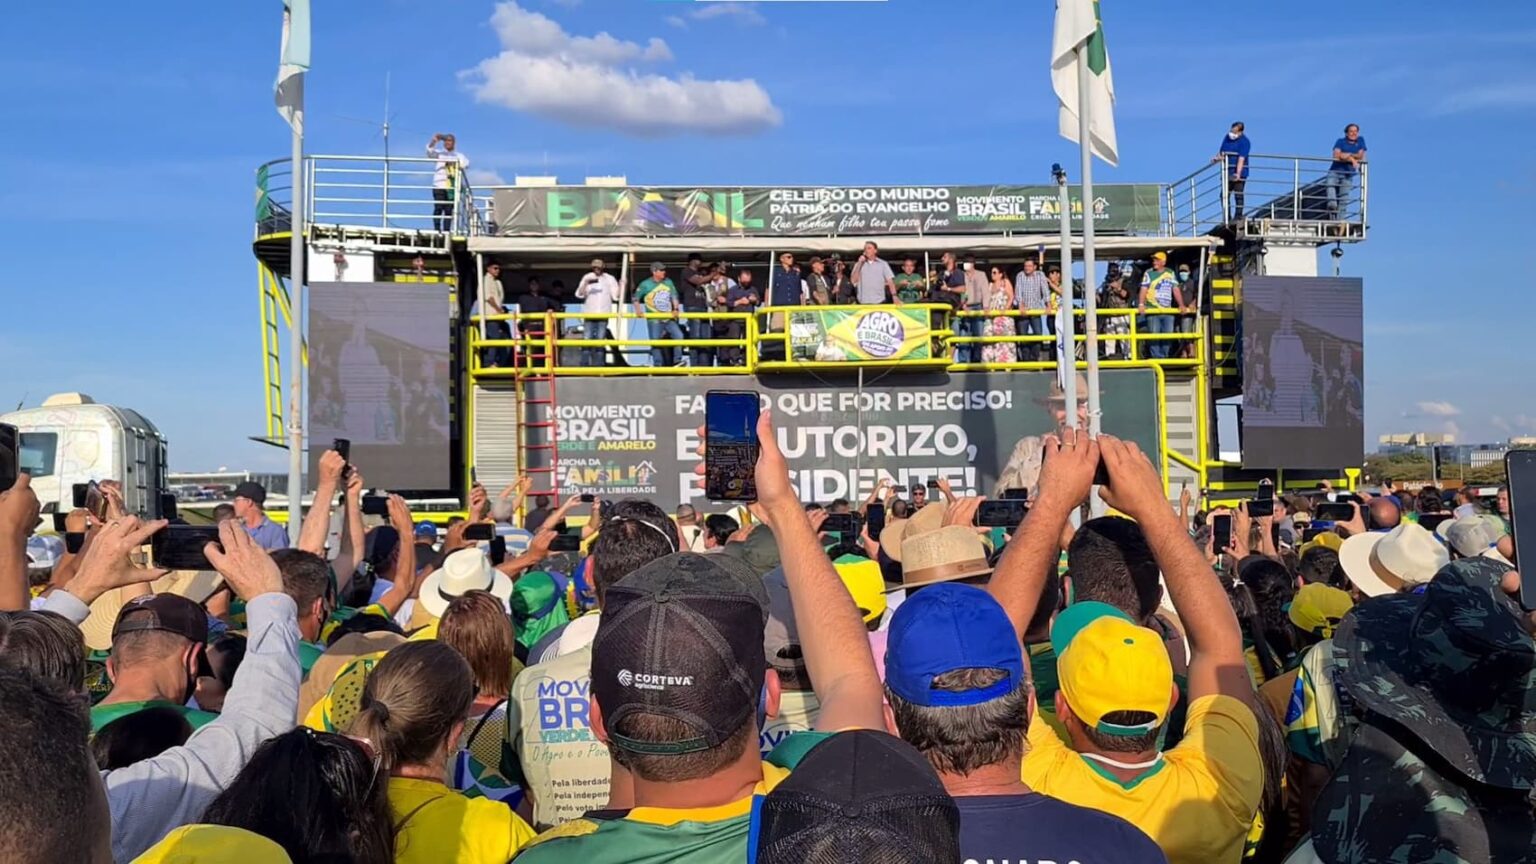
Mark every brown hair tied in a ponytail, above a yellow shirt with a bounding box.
[349,641,475,775]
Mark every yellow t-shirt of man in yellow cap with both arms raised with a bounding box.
[1023,695,1264,864]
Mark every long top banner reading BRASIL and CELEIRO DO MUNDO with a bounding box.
[493,184,1163,237]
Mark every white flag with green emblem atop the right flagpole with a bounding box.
[1051,0,1120,164]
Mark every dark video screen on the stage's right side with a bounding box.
[1241,277,1366,470]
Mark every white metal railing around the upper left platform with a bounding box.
[257,155,484,237]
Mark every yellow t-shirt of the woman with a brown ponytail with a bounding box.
[389,776,535,864]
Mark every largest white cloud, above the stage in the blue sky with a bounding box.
[459,0,782,135]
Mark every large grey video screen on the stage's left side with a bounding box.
[309,281,452,490]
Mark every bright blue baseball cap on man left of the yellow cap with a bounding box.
[885,583,1025,707]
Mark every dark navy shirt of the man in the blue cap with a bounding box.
[955,792,1167,864]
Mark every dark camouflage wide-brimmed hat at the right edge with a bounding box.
[1333,558,1536,793]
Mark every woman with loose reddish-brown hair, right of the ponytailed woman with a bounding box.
[438,590,531,815]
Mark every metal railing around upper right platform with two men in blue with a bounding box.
[1164,154,1370,241]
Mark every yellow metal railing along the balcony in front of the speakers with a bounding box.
[464,306,1206,378]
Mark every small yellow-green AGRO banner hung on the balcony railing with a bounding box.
[788,306,932,363]
